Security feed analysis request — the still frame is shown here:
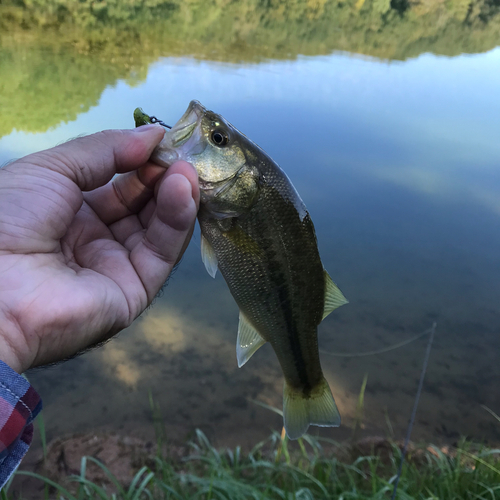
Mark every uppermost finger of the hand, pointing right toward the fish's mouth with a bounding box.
[20,125,165,191]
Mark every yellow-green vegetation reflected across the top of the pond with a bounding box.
[0,0,500,137]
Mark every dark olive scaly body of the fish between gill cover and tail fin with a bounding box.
[199,170,325,394]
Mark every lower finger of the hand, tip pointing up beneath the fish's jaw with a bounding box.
[130,161,200,302]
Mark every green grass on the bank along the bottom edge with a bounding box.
[5,431,500,500]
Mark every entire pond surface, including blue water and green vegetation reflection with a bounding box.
[0,0,500,452]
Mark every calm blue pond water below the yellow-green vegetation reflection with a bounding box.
[0,2,500,450]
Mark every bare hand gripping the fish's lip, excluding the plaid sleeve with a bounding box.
[0,125,199,373]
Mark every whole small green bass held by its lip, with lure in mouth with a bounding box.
[134,101,348,439]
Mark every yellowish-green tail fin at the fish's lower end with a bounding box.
[283,379,340,439]
